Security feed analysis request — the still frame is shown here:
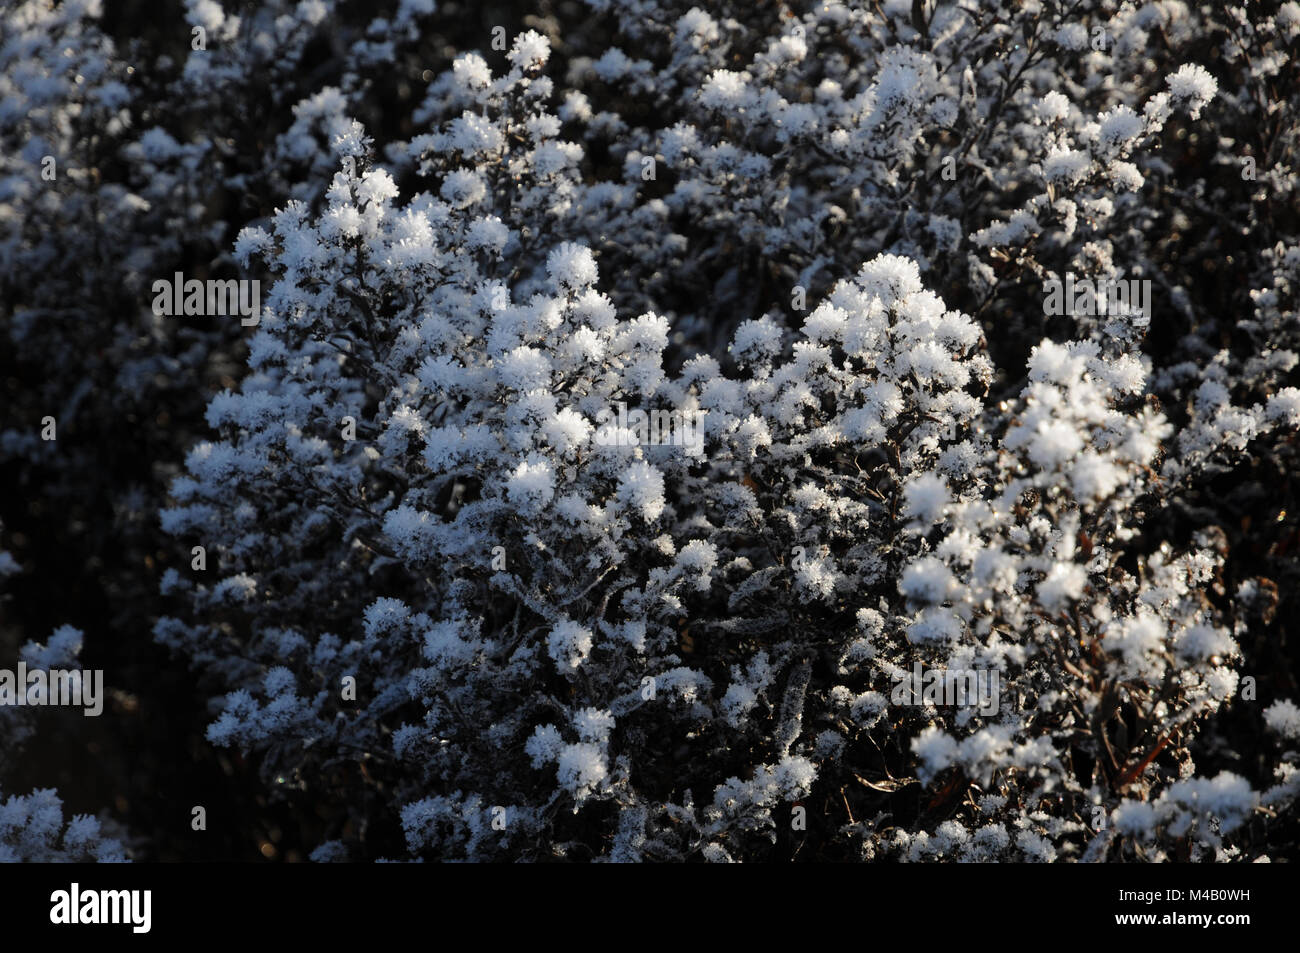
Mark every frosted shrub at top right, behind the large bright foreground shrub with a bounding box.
[546,0,1248,345]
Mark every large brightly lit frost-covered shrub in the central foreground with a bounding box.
[157,98,1294,859]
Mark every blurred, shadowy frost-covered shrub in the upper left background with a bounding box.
[0,0,470,852]
